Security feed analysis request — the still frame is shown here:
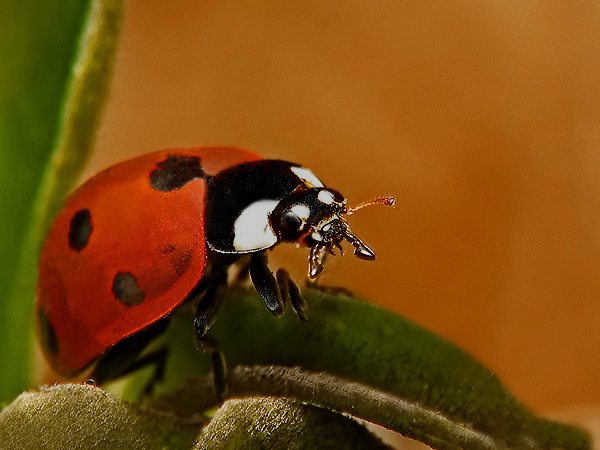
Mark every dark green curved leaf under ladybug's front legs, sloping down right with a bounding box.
[148,291,590,449]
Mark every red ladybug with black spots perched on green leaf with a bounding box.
[35,147,393,382]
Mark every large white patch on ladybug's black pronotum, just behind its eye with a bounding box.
[233,200,279,252]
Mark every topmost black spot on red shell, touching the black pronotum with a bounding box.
[150,155,206,192]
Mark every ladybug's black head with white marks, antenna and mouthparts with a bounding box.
[269,188,394,278]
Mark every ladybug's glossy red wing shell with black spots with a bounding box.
[36,148,259,375]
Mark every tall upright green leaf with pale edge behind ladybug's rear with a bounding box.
[0,0,123,401]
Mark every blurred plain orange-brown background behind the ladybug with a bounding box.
[86,0,600,418]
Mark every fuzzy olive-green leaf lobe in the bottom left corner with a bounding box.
[0,384,200,450]
